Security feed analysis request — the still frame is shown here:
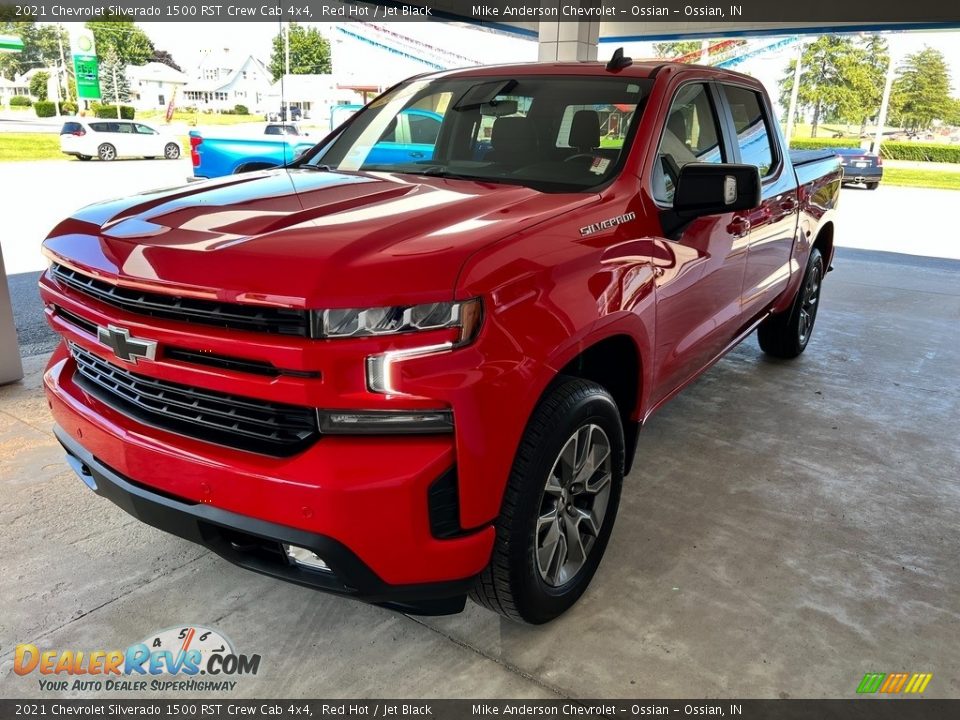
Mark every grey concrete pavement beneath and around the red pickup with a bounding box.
[0,246,960,700]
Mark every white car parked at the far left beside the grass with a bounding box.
[60,118,180,160]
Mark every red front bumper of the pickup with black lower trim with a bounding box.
[44,346,494,605]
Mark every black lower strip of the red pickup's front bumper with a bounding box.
[54,427,474,615]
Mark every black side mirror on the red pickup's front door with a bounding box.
[673,163,760,218]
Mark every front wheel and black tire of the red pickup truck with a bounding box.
[470,378,624,624]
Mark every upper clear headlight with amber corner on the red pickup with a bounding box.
[311,298,480,345]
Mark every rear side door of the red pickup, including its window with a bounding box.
[719,83,800,318]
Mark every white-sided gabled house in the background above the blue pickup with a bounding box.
[178,49,272,113]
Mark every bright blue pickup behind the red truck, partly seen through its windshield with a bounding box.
[190,106,442,180]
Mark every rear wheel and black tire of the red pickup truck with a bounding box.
[757,248,824,359]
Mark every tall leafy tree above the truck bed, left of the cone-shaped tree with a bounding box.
[780,35,869,137]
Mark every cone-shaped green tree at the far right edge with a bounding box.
[890,47,955,130]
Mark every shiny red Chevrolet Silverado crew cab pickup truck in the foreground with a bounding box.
[40,55,842,623]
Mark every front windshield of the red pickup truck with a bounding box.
[301,76,652,192]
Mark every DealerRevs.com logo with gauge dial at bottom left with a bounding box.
[13,626,260,692]
